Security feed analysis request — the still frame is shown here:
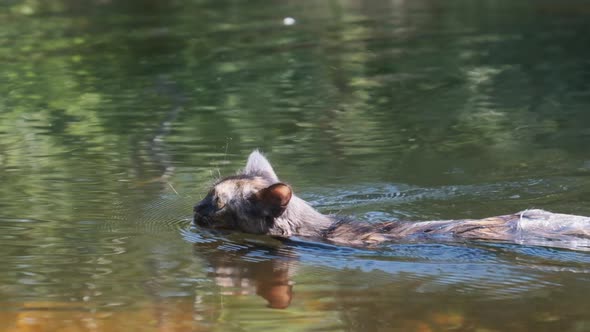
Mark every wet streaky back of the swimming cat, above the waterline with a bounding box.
[326,209,590,249]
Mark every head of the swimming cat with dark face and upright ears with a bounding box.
[194,150,292,234]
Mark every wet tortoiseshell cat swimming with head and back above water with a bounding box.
[194,151,590,250]
